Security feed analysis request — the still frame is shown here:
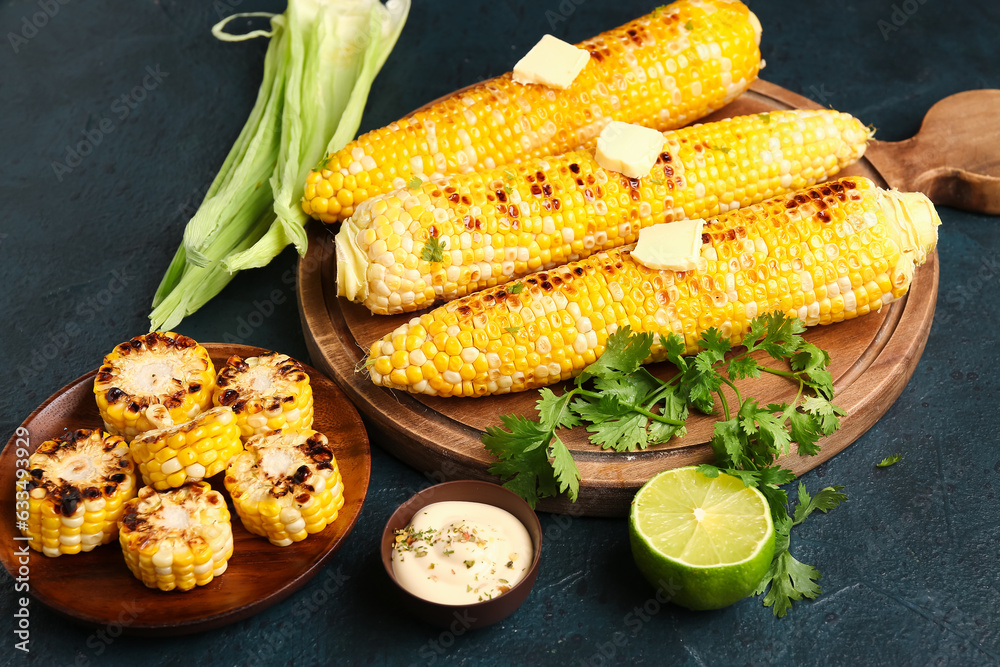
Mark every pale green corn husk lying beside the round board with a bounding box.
[149,0,410,330]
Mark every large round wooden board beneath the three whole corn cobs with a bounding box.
[298,81,938,516]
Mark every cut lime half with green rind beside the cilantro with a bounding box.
[629,467,774,609]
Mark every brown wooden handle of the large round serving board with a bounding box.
[865,89,1000,215]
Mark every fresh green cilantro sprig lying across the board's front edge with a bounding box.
[482,313,847,617]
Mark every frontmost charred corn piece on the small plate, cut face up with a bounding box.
[118,482,233,591]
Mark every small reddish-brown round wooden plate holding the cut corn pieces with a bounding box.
[0,343,371,635]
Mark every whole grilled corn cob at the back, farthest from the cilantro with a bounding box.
[302,0,760,222]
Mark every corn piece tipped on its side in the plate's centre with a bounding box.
[129,407,243,491]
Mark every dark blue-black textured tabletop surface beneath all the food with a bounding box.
[0,0,1000,665]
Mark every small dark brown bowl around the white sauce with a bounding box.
[382,480,542,630]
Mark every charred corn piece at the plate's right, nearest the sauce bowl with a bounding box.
[225,430,344,547]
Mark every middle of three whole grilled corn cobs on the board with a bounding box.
[337,109,868,315]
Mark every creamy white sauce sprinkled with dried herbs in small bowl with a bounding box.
[392,501,534,605]
